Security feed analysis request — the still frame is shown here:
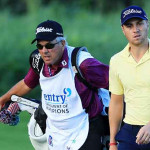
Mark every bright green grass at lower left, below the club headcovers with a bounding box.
[0,112,34,150]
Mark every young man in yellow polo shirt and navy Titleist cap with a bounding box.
[109,6,150,150]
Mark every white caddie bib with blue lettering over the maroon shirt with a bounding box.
[40,46,89,150]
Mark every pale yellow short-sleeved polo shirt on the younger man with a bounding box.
[109,41,150,125]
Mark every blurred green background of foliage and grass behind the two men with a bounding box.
[0,0,150,150]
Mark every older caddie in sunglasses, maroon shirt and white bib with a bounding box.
[0,20,109,150]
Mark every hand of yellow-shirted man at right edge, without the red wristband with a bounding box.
[136,122,150,144]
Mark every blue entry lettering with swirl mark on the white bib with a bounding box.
[44,88,72,104]
